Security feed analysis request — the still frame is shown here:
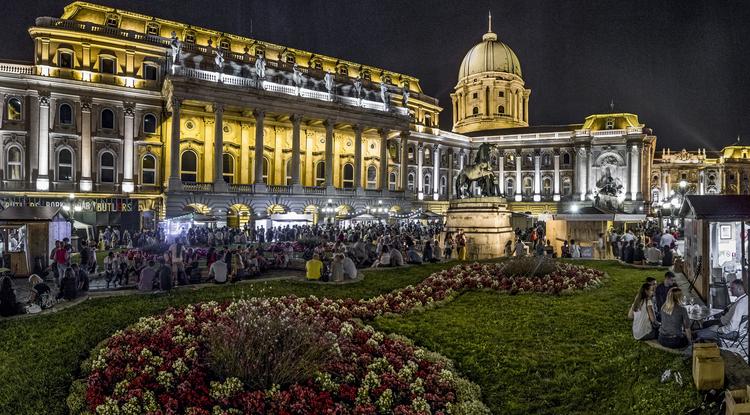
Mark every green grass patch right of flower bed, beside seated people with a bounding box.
[375,263,700,414]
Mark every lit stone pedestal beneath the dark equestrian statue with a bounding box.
[445,197,515,260]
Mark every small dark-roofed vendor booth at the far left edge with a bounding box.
[0,206,71,276]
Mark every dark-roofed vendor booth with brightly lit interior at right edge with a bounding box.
[680,195,750,308]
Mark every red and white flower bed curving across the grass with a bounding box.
[69,262,603,414]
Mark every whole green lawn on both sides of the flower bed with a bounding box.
[0,263,698,414]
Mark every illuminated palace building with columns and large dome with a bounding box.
[0,2,747,228]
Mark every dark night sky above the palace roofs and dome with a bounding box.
[0,0,750,149]
